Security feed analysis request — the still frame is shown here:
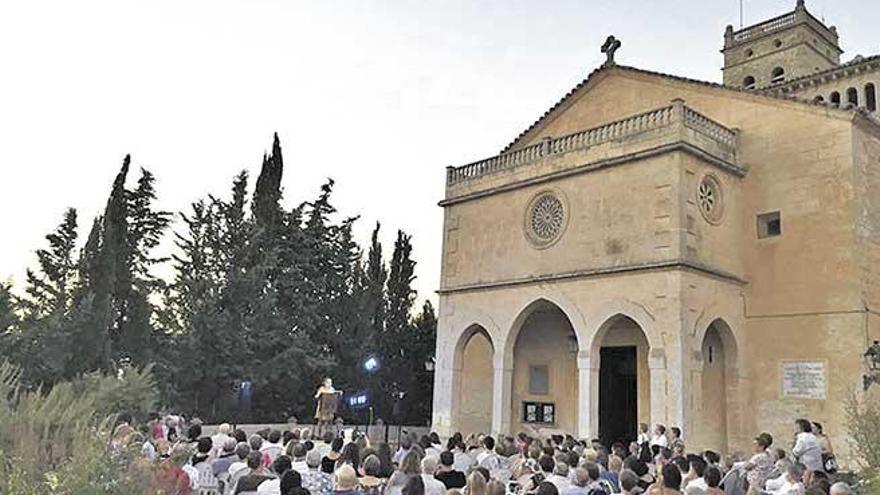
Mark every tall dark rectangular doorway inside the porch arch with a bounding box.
[599,347,638,446]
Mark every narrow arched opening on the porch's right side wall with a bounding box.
[695,319,736,452]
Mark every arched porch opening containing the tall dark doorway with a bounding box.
[594,315,651,445]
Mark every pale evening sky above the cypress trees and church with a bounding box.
[0,0,880,299]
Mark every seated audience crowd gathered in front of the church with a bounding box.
[115,417,853,495]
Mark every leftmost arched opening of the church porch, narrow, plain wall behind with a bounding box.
[455,325,495,435]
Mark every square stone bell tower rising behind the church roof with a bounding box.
[721,0,843,89]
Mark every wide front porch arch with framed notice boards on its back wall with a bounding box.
[510,300,578,432]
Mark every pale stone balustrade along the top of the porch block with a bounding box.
[446,100,737,186]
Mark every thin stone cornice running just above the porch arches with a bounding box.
[437,259,748,295]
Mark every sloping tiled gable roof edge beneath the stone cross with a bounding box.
[501,64,868,153]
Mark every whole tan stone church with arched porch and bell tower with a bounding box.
[433,1,880,462]
